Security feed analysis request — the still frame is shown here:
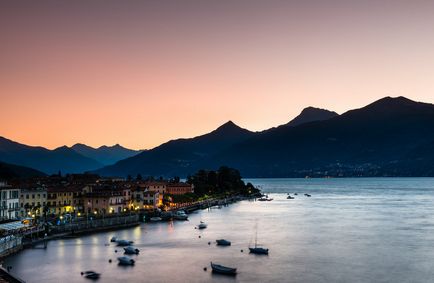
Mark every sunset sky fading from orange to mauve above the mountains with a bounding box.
[0,0,434,149]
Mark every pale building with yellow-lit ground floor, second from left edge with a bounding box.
[20,190,47,217]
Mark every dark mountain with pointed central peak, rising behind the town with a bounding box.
[96,121,255,179]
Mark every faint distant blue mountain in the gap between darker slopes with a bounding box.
[71,143,142,165]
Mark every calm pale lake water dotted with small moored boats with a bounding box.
[4,178,434,282]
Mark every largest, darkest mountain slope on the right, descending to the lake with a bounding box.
[214,97,434,177]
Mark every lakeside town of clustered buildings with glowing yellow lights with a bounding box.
[0,174,194,221]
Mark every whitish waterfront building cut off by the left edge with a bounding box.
[0,182,20,220]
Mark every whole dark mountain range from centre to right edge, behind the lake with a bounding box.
[97,97,434,177]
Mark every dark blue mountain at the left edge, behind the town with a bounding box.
[0,137,103,174]
